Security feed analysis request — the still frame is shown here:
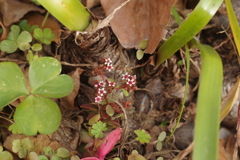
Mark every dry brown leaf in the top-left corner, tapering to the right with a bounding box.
[0,0,45,26]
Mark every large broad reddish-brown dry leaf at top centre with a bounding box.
[101,0,175,53]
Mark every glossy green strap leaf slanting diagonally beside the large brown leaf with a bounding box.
[156,0,223,66]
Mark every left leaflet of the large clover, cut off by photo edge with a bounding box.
[0,62,29,110]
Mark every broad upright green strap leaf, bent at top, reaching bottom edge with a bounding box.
[193,44,223,160]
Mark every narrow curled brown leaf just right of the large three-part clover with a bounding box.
[61,68,84,110]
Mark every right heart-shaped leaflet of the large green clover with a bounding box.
[29,57,74,98]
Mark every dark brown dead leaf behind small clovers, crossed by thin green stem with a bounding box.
[22,12,61,43]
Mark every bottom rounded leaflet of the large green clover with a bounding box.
[9,95,61,136]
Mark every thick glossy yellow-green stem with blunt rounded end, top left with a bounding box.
[38,0,91,31]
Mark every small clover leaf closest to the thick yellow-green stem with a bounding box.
[33,28,55,44]
